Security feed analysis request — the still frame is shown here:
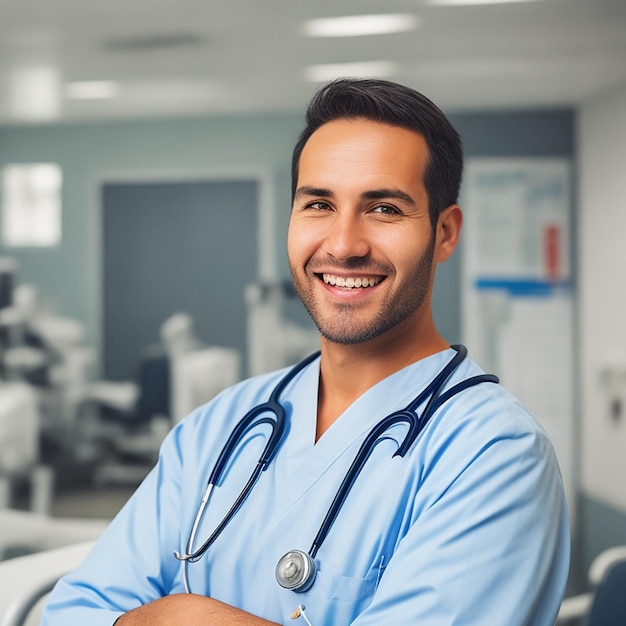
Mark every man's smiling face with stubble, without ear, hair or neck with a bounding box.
[288,114,436,344]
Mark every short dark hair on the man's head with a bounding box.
[291,78,463,228]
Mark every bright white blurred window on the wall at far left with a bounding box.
[2,163,62,247]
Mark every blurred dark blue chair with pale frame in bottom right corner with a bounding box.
[556,546,626,626]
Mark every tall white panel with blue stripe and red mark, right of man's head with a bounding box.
[462,158,575,511]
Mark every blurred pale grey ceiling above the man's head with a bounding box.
[0,0,626,124]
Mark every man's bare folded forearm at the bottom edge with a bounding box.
[115,594,276,626]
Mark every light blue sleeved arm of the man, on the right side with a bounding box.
[352,408,569,626]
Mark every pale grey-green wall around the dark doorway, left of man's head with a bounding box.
[0,114,301,354]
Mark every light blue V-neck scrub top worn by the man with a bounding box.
[41,350,570,626]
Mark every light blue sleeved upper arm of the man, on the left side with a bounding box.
[41,423,190,626]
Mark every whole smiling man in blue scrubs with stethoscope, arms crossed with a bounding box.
[42,80,569,626]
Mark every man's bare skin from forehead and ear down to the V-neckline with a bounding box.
[288,117,462,437]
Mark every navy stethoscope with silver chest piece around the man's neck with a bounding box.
[174,345,499,593]
